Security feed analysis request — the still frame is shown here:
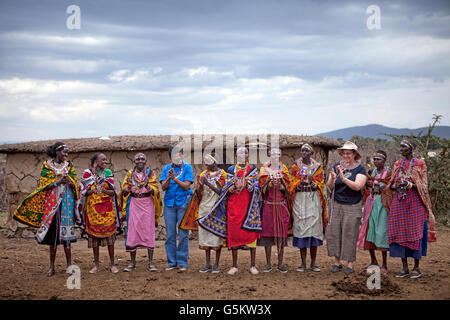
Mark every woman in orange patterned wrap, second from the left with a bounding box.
[78,153,121,274]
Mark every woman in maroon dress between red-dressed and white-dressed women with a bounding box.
[257,148,290,273]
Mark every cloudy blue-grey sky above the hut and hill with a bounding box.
[0,0,450,142]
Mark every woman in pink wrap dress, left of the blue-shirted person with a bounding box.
[122,153,162,272]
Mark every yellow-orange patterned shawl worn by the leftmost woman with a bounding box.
[13,161,78,228]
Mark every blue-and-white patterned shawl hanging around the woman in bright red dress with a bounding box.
[197,165,262,239]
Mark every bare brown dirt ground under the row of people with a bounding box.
[0,231,450,300]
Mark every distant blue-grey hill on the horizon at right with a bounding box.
[317,124,450,140]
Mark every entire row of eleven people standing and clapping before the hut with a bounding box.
[14,140,435,278]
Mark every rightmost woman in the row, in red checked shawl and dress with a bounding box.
[387,140,436,278]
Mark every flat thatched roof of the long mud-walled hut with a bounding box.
[0,134,340,153]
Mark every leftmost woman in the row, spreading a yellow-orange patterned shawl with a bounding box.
[14,142,80,277]
